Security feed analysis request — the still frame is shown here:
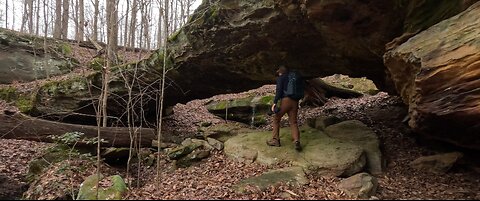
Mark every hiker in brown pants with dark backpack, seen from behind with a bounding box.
[267,66,303,151]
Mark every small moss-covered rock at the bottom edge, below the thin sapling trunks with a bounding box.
[77,174,128,200]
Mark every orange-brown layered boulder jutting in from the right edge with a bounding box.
[384,3,480,150]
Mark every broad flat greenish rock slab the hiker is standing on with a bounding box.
[224,126,366,177]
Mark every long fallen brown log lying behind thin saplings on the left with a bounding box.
[0,111,156,147]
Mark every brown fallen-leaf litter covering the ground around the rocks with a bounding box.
[0,85,480,200]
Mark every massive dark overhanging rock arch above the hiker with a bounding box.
[164,0,405,101]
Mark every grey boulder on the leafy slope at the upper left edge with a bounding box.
[0,28,77,84]
